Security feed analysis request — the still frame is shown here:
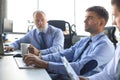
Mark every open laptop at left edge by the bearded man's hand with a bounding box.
[0,34,21,55]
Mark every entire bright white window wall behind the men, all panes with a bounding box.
[7,0,112,35]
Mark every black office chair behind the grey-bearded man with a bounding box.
[48,20,75,49]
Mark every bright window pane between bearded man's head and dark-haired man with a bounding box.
[39,0,74,24]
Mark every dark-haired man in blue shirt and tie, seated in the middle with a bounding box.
[23,6,114,80]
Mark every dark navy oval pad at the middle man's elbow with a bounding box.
[80,60,98,75]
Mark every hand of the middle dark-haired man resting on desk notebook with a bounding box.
[23,53,48,69]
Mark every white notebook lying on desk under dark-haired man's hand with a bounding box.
[14,57,35,69]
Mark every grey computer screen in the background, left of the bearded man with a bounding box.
[3,19,13,33]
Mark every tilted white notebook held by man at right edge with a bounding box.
[61,56,80,80]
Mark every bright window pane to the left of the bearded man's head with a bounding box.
[7,0,37,32]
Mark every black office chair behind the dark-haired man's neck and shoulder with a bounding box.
[104,26,118,48]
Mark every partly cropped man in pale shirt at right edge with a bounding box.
[80,0,120,80]
